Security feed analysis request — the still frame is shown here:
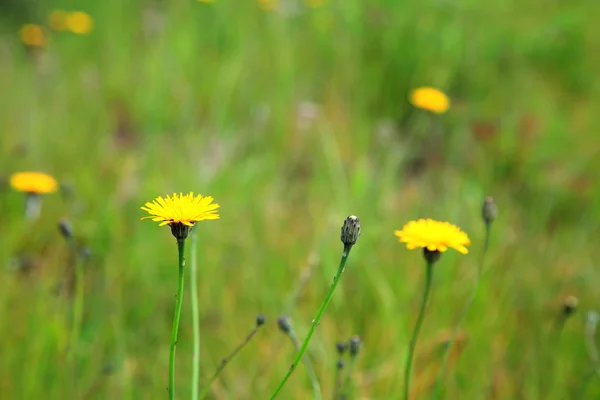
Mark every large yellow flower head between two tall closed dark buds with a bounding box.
[394,219,471,254]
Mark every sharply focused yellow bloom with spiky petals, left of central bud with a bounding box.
[141,192,219,226]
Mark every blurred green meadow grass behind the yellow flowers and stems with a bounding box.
[0,0,600,400]
